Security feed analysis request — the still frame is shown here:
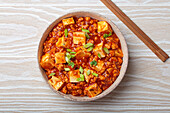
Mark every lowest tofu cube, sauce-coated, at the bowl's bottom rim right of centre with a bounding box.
[85,83,102,97]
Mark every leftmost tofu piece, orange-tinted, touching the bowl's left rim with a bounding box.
[40,53,54,69]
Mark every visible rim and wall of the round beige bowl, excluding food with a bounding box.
[38,11,128,101]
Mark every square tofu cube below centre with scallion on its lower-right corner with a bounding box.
[68,70,80,82]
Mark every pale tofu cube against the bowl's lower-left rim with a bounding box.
[48,76,64,90]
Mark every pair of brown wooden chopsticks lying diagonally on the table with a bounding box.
[101,0,169,62]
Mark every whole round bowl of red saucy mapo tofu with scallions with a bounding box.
[38,12,128,101]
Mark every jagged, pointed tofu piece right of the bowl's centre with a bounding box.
[93,42,105,57]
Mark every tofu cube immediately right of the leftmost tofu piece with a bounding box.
[55,52,66,64]
